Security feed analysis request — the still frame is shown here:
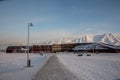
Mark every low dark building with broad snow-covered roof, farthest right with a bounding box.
[73,43,120,53]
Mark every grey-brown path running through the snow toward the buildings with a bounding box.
[33,55,78,80]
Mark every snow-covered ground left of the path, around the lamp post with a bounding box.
[0,53,50,80]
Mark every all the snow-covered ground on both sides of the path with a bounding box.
[0,52,120,80]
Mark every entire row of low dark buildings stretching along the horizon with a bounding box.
[6,43,120,53]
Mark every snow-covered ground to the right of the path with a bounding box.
[58,53,120,80]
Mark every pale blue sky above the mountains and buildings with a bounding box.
[0,0,120,44]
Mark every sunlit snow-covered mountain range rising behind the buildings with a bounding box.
[45,33,120,46]
